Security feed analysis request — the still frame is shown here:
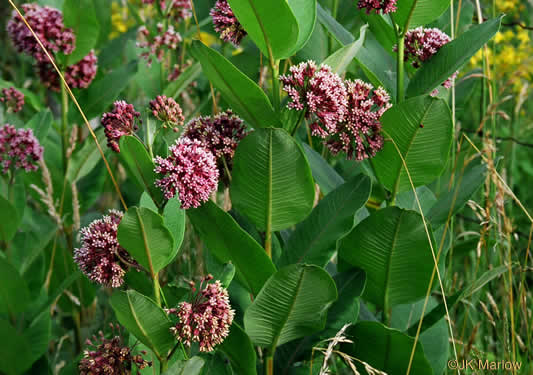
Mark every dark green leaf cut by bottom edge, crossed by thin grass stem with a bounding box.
[341,322,433,375]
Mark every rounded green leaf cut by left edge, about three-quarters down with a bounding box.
[0,258,31,314]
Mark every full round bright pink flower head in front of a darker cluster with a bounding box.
[154,138,219,209]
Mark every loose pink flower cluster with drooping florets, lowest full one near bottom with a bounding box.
[166,275,235,352]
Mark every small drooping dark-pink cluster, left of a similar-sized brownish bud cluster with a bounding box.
[100,100,141,152]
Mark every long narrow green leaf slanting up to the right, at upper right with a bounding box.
[407,17,502,97]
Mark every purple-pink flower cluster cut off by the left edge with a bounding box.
[0,124,43,173]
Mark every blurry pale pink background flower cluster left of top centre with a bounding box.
[137,23,182,65]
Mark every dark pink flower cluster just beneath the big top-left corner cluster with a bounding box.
[37,51,98,91]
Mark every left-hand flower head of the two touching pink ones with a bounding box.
[280,61,348,138]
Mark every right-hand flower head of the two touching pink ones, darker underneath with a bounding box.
[326,80,391,161]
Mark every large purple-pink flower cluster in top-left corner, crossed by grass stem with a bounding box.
[7,3,76,63]
